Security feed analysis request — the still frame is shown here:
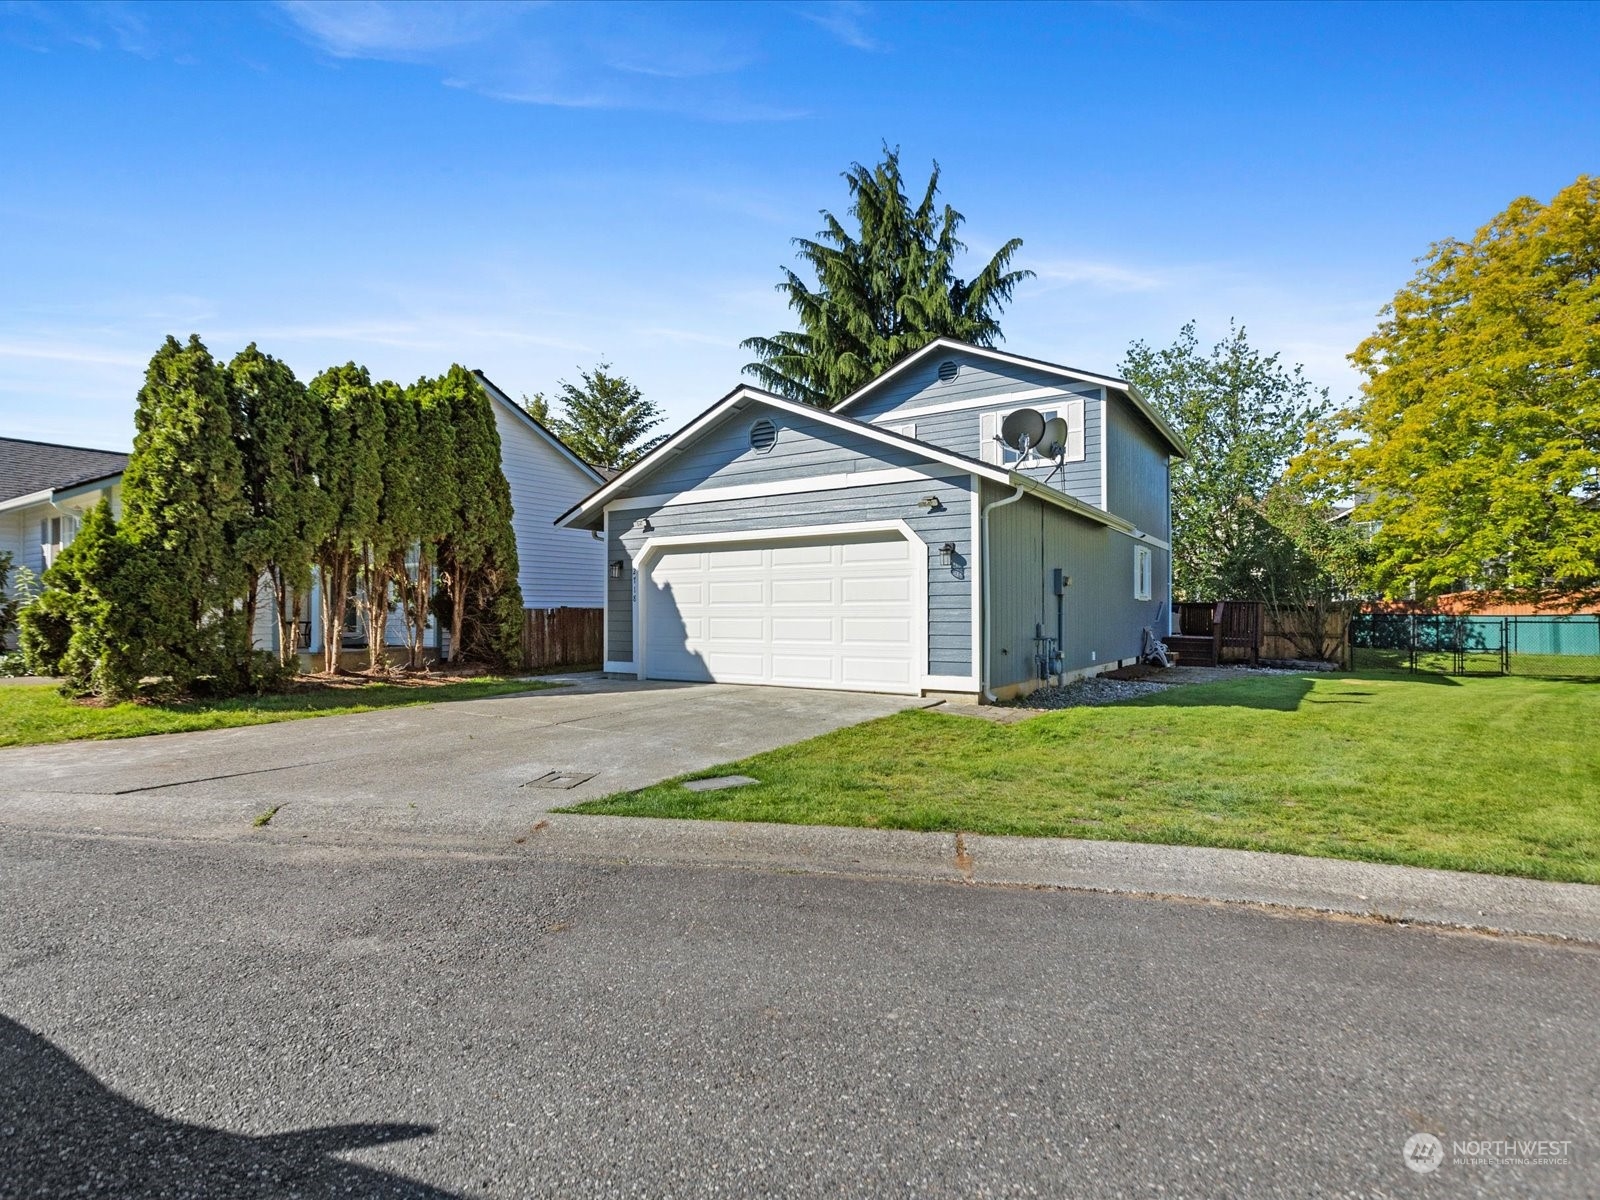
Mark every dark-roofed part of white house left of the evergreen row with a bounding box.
[0,437,128,649]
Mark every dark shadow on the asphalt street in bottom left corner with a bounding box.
[0,1016,458,1200]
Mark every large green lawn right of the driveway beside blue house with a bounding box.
[570,672,1600,883]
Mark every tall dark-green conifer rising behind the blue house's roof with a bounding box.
[741,146,1034,405]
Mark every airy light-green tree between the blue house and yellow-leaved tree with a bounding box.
[1122,322,1328,600]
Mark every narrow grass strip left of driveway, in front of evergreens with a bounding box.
[0,677,557,746]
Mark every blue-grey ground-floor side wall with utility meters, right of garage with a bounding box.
[984,483,1168,688]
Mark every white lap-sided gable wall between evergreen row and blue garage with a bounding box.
[493,400,605,608]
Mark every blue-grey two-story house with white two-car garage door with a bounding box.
[558,339,1186,699]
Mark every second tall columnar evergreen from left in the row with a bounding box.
[227,342,330,666]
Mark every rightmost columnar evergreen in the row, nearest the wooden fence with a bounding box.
[435,365,523,666]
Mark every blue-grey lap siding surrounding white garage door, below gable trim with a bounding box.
[606,475,973,675]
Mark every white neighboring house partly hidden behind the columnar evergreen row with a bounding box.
[0,371,605,662]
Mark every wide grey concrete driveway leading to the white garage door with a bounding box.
[0,677,928,840]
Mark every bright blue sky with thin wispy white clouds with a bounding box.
[0,3,1600,448]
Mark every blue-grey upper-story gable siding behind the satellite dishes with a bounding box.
[846,354,1106,509]
